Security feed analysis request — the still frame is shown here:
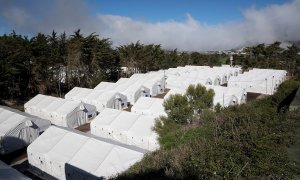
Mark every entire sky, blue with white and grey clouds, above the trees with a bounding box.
[0,0,300,51]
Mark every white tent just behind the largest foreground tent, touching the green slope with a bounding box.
[91,108,159,150]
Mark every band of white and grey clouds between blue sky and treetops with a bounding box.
[0,0,300,51]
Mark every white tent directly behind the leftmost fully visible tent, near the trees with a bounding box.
[65,87,127,112]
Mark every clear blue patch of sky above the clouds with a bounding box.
[87,0,287,25]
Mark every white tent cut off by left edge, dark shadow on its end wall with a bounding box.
[0,106,50,154]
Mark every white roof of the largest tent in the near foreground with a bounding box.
[27,126,144,177]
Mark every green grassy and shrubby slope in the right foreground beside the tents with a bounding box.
[118,80,300,179]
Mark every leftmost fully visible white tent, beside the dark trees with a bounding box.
[24,94,96,128]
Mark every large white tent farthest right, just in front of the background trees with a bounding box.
[228,68,287,95]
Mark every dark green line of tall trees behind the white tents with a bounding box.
[0,30,300,100]
